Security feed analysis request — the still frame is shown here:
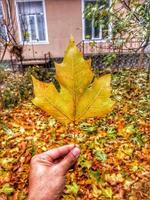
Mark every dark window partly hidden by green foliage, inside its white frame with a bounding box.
[83,0,109,40]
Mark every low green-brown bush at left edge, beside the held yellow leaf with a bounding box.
[0,66,54,108]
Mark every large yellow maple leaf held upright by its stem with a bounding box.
[32,38,114,124]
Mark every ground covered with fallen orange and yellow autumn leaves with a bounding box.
[0,69,150,200]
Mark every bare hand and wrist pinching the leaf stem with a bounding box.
[28,144,80,200]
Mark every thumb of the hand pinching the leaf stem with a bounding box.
[58,147,80,175]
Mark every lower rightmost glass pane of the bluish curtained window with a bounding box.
[37,15,46,41]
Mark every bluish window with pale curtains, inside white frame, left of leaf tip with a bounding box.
[17,0,46,42]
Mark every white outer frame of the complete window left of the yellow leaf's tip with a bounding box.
[15,0,49,45]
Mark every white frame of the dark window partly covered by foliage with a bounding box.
[81,0,112,42]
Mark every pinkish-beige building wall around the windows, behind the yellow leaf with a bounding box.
[0,0,144,60]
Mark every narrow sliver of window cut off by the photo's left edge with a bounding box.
[0,1,7,43]
